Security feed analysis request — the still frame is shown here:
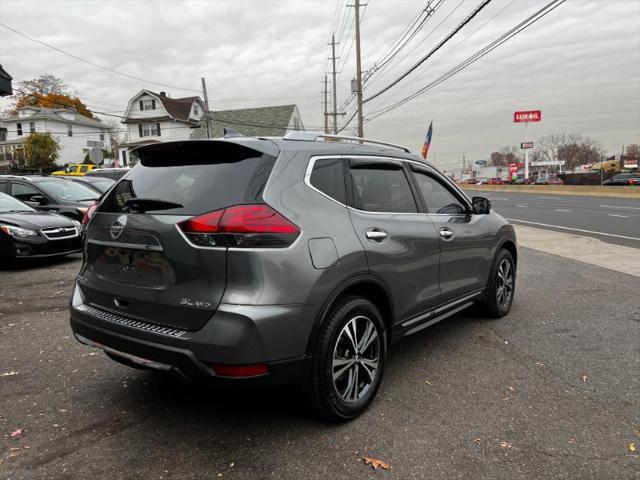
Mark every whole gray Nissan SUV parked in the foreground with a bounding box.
[71,133,517,420]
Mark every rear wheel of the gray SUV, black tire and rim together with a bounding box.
[305,295,387,421]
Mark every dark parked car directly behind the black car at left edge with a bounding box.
[0,175,100,221]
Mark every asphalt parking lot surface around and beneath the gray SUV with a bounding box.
[0,248,640,479]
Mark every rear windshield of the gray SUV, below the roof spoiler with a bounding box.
[99,144,275,215]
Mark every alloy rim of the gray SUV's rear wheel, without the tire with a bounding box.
[331,315,381,402]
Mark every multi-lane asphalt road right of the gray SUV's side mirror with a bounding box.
[465,188,640,248]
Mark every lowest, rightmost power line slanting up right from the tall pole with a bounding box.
[368,0,566,121]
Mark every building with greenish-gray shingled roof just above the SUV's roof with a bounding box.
[191,105,304,139]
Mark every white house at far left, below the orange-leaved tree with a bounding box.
[0,107,111,169]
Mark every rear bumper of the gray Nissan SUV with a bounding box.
[70,289,309,386]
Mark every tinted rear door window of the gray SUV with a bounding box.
[350,163,418,213]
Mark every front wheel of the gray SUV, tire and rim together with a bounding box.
[480,248,516,318]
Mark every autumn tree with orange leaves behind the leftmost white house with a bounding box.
[9,74,94,118]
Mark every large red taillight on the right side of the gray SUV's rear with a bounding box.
[178,204,300,248]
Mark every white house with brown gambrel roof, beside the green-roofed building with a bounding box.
[118,90,204,165]
